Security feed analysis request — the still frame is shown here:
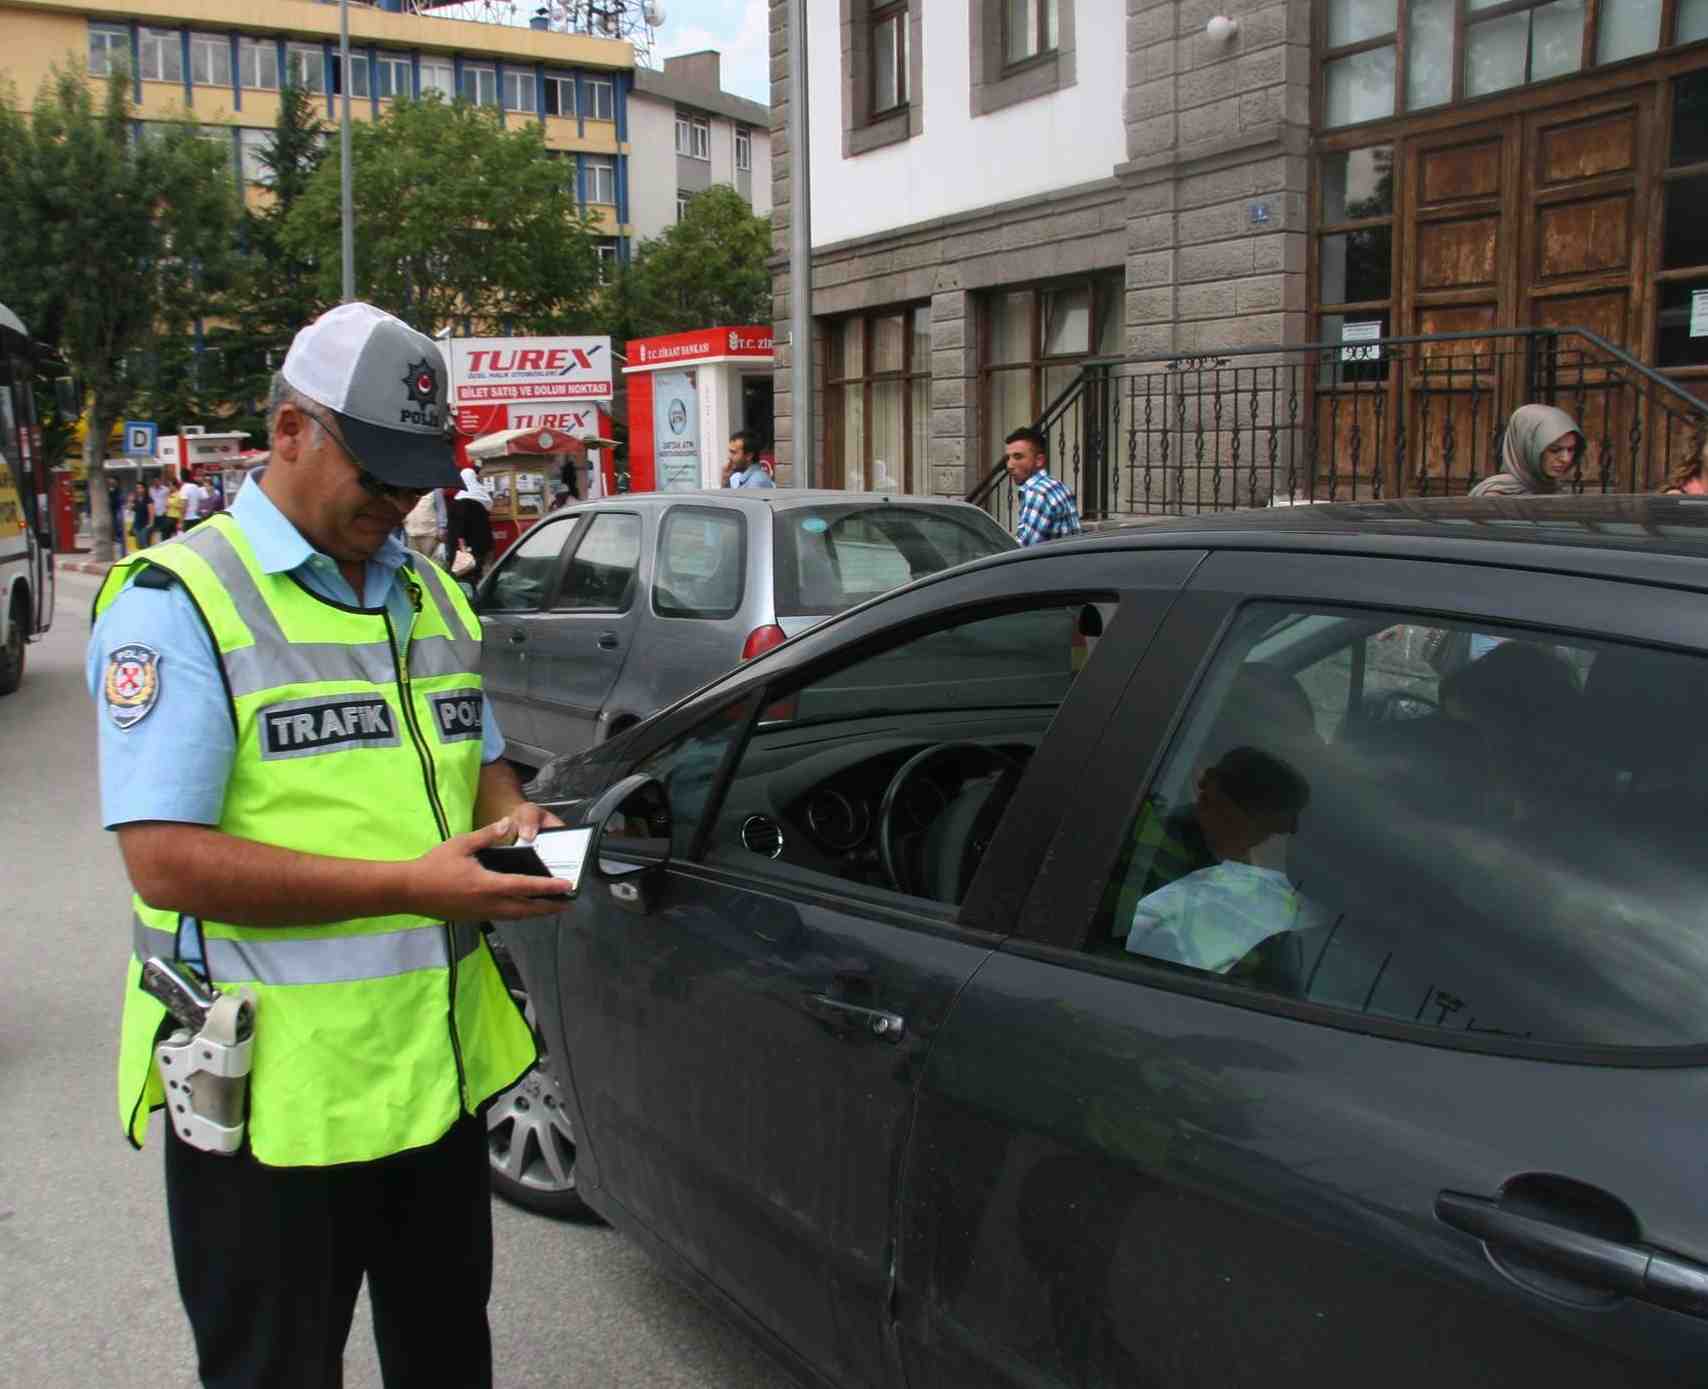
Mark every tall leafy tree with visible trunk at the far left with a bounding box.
[0,65,237,559]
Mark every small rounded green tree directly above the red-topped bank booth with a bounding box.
[610,185,772,338]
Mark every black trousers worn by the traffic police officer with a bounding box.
[164,1117,492,1389]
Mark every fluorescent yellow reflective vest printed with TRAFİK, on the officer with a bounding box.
[96,514,535,1167]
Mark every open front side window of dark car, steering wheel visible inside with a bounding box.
[705,601,1114,905]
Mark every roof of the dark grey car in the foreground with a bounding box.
[975,494,1708,589]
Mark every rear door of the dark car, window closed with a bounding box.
[897,552,1708,1389]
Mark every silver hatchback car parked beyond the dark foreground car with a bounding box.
[475,489,1015,767]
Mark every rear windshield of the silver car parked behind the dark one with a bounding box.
[772,502,1015,617]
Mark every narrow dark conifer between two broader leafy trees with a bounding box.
[225,85,327,429]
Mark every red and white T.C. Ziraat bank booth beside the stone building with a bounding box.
[623,325,774,492]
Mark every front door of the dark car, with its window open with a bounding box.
[557,554,1196,1386]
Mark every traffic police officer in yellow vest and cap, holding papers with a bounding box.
[89,304,570,1387]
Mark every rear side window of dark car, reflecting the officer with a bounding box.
[1088,605,1708,1046]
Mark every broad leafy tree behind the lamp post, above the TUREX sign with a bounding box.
[280,96,600,333]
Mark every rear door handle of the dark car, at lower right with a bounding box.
[1435,1191,1708,1317]
